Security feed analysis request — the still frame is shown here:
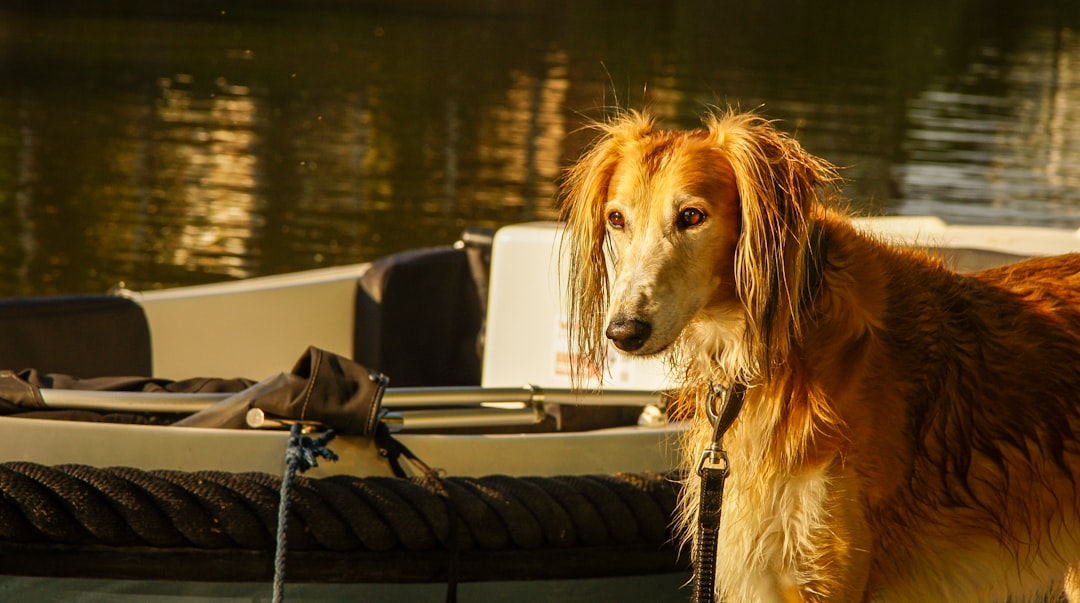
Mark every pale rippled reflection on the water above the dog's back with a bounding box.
[894,20,1080,227]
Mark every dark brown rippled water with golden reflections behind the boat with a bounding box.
[0,0,1080,296]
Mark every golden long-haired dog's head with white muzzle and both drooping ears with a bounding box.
[563,111,836,384]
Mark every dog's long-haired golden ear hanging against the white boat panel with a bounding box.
[562,111,654,384]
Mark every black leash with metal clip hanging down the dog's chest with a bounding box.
[692,383,746,603]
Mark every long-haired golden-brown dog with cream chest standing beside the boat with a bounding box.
[563,111,1080,603]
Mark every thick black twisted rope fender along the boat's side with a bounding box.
[0,463,677,551]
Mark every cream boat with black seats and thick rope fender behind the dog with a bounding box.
[0,216,1080,601]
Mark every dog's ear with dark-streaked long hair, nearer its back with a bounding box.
[706,111,838,380]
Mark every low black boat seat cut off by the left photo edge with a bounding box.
[0,295,152,377]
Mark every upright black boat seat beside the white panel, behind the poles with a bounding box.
[353,246,484,387]
